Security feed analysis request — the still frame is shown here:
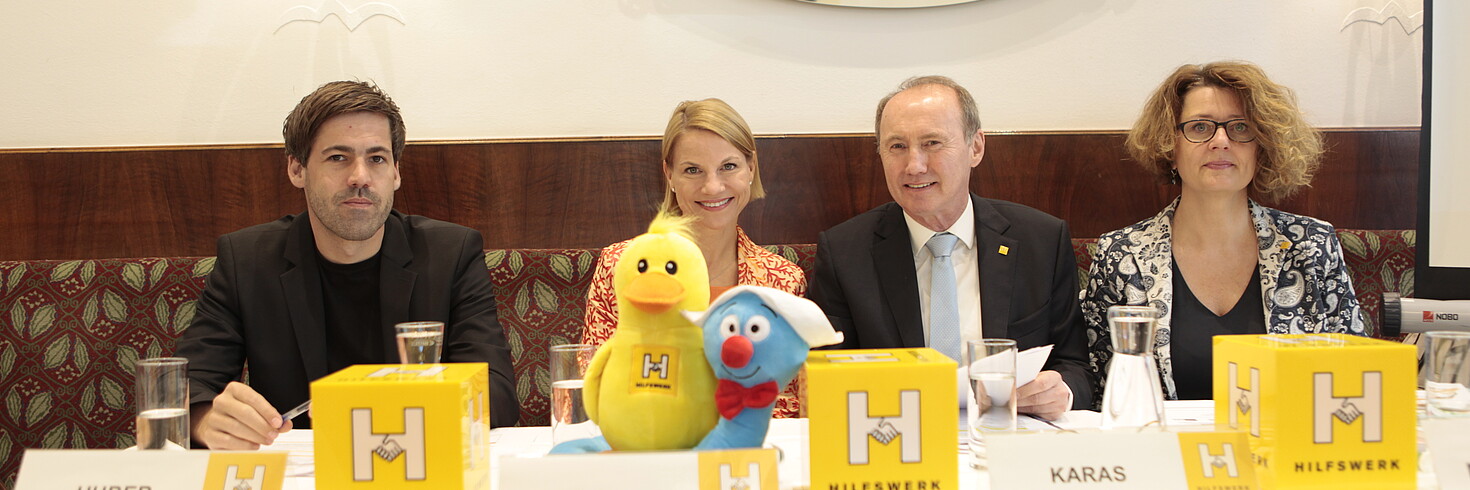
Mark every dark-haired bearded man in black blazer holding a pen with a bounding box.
[176,81,520,449]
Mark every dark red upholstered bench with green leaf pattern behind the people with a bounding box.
[0,235,1414,489]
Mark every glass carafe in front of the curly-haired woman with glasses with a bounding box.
[1103,306,1164,430]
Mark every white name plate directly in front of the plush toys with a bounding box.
[495,449,781,490]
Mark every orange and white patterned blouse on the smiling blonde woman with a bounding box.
[582,227,807,416]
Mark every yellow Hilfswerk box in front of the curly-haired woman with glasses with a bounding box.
[1214,334,1417,489]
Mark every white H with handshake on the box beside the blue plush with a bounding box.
[847,390,923,465]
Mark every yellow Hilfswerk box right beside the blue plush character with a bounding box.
[806,349,960,489]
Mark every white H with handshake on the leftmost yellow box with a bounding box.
[353,408,428,481]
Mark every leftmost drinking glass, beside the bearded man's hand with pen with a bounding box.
[134,358,190,449]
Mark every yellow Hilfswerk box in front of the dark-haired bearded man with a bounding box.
[312,362,490,489]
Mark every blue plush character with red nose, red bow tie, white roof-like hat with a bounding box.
[686,285,842,449]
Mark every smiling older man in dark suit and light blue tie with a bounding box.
[809,77,1092,419]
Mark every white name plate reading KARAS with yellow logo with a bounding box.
[988,431,1258,490]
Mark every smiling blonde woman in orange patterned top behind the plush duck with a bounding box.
[582,99,807,416]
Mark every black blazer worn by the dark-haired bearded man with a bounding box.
[176,210,520,428]
